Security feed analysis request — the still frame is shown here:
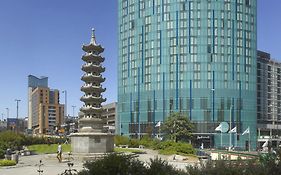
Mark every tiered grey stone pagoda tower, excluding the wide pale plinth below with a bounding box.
[79,30,106,132]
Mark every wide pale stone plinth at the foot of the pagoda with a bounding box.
[70,132,114,153]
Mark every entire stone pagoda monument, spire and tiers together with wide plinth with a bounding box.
[71,29,113,153]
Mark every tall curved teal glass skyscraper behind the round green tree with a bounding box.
[117,0,257,149]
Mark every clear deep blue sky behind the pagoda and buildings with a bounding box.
[0,0,281,118]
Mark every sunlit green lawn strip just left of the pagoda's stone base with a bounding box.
[27,144,71,154]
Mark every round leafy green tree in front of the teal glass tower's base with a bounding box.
[161,112,194,142]
